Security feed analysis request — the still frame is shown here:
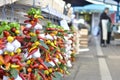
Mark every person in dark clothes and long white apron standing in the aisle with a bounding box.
[99,8,111,46]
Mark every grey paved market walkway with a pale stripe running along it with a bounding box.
[64,38,120,80]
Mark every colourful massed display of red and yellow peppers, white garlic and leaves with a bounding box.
[0,5,75,80]
